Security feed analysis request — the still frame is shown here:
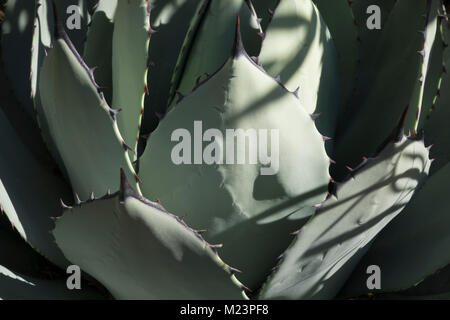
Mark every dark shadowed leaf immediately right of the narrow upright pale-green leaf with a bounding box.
[142,0,201,134]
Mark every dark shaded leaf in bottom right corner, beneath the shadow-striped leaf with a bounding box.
[343,164,450,296]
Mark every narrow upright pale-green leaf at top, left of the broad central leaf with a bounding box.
[112,0,151,159]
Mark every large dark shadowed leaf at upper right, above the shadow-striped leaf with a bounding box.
[333,0,437,179]
